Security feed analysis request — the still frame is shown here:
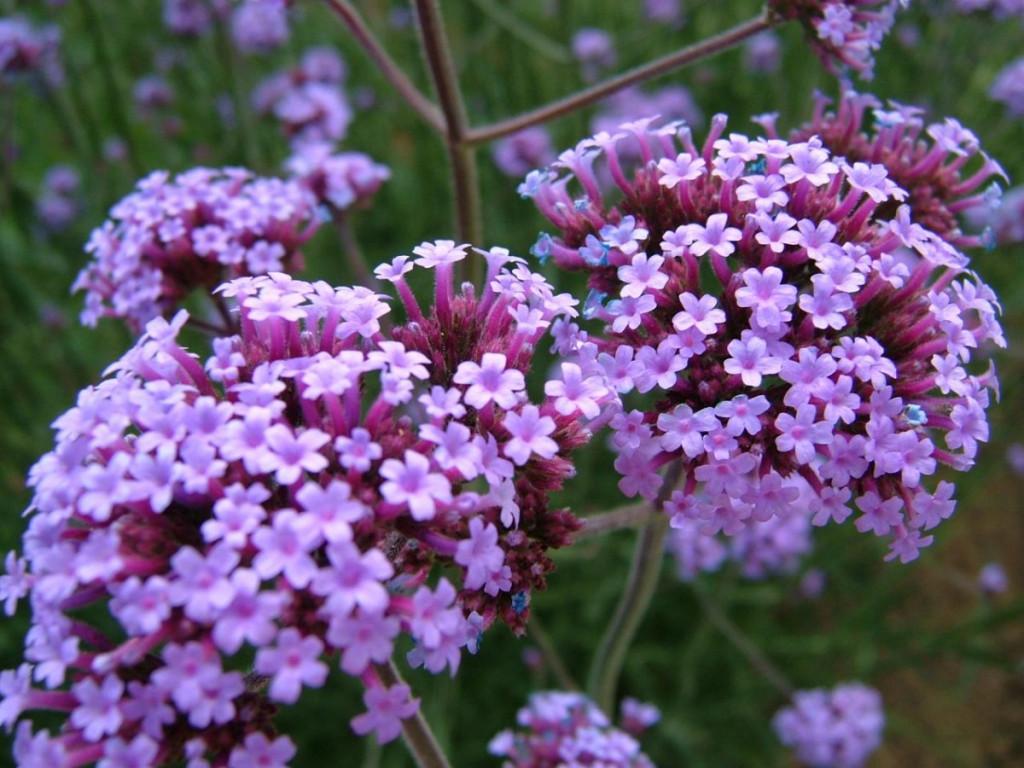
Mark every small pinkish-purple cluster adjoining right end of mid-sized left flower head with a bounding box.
[287,142,391,212]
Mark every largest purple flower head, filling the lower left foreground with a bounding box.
[0,241,588,766]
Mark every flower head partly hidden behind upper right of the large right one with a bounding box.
[790,90,1007,243]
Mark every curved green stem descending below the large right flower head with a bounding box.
[587,461,682,714]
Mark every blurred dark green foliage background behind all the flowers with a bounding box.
[0,0,1024,768]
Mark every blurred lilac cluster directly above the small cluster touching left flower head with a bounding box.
[252,48,352,144]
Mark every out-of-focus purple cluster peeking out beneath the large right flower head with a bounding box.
[667,509,813,582]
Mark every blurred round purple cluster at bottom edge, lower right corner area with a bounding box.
[773,683,885,768]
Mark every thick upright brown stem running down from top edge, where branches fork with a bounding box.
[415,0,482,280]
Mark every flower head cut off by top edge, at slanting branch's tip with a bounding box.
[768,0,909,80]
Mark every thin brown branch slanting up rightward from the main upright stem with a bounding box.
[466,11,776,144]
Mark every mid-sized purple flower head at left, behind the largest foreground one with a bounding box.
[74,168,316,330]
